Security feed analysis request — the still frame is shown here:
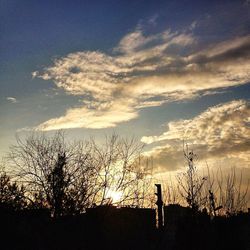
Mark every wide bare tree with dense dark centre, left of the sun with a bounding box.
[8,132,98,216]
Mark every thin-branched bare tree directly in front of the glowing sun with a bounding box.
[89,134,151,207]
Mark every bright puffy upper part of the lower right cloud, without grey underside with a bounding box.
[142,100,250,148]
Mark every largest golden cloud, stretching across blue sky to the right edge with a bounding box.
[33,24,250,130]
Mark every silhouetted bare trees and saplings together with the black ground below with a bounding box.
[0,133,250,250]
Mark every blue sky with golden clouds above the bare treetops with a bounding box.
[0,0,250,179]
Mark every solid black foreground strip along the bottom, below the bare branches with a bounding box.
[0,205,250,250]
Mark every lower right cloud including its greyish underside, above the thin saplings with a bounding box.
[141,100,250,170]
